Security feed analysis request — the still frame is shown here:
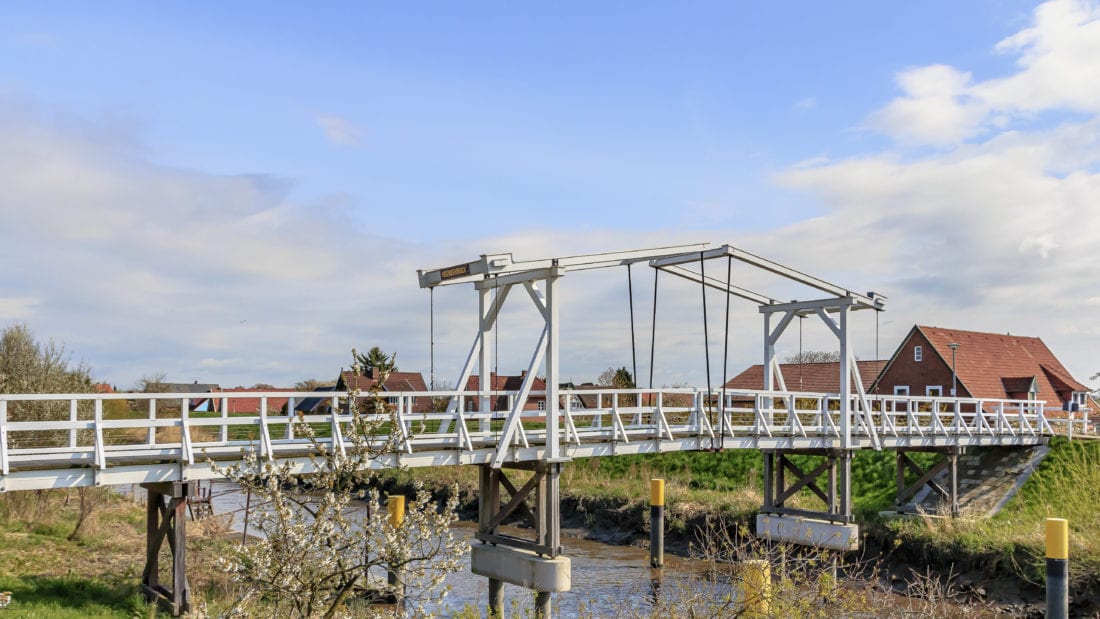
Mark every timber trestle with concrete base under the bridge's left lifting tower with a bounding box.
[470,461,571,617]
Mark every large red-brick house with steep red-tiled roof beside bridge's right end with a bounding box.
[872,324,1089,408]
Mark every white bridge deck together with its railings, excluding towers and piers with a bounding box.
[0,389,1088,491]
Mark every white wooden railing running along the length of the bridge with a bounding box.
[0,388,1088,474]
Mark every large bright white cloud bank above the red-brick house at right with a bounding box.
[758,0,1100,379]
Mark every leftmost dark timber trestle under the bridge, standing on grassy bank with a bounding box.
[141,482,195,617]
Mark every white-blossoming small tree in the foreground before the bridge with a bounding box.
[211,353,465,617]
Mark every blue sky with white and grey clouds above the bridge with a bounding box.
[0,0,1100,388]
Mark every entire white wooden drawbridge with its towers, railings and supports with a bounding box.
[0,243,1088,615]
